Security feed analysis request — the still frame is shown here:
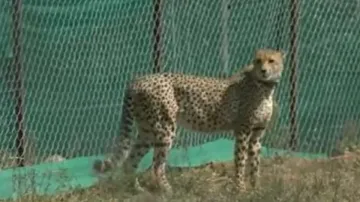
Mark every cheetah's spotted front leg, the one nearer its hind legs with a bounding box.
[234,125,251,191]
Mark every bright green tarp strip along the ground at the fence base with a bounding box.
[0,139,325,199]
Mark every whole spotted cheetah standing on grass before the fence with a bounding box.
[94,48,285,192]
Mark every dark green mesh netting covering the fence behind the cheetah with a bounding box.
[0,0,360,200]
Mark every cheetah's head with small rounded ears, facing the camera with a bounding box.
[253,49,286,84]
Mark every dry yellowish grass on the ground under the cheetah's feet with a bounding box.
[2,153,360,202]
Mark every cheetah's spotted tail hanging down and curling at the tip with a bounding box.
[93,91,134,172]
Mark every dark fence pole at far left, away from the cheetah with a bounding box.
[12,0,25,167]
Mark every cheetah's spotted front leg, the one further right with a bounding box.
[248,127,265,188]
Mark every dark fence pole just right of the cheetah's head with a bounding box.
[289,0,299,151]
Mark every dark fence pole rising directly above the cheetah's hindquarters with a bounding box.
[153,0,163,73]
